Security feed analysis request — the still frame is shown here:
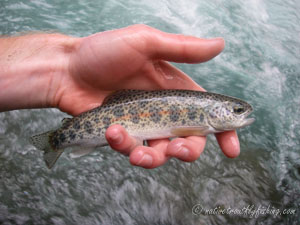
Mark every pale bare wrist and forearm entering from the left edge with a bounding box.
[0,34,77,111]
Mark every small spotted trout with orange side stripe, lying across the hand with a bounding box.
[31,89,255,169]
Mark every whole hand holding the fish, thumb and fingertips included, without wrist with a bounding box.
[57,25,240,168]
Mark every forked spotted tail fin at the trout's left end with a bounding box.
[30,131,63,169]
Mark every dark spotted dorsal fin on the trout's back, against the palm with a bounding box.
[102,89,147,106]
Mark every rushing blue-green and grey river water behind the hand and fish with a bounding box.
[0,0,300,224]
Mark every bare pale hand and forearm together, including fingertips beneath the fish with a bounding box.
[0,25,240,168]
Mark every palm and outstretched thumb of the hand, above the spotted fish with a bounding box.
[62,25,224,115]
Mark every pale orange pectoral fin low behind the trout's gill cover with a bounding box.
[171,126,210,137]
